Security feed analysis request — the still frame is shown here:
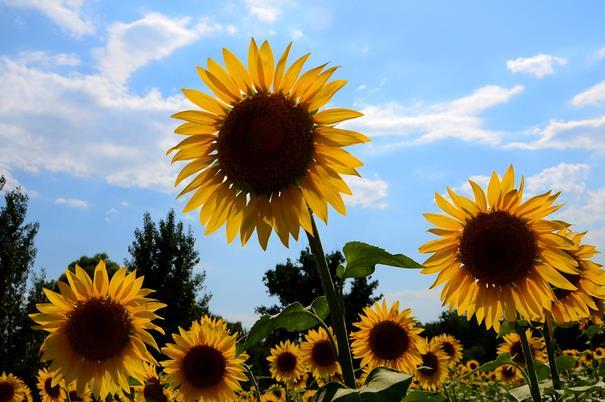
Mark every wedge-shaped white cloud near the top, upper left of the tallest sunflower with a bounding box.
[96,13,221,83]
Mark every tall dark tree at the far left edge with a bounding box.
[0,177,38,372]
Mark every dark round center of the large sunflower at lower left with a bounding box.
[67,297,134,361]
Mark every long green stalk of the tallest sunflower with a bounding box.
[307,215,356,389]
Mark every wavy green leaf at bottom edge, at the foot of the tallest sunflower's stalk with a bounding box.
[312,367,412,402]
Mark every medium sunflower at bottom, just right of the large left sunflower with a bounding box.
[162,318,247,402]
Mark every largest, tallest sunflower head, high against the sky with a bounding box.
[169,39,369,248]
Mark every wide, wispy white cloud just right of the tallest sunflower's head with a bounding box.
[346,85,523,146]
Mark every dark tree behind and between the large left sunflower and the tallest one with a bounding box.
[125,210,211,342]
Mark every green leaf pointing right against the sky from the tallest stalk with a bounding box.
[337,241,423,279]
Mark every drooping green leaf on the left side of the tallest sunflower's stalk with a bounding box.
[238,296,329,353]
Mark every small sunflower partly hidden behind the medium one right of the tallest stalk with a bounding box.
[414,340,449,391]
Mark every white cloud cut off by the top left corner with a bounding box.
[2,0,95,37]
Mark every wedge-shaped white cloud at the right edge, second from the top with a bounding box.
[506,115,605,152]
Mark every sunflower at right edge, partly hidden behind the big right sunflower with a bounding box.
[551,229,605,324]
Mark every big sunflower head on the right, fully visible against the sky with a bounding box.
[420,166,580,331]
